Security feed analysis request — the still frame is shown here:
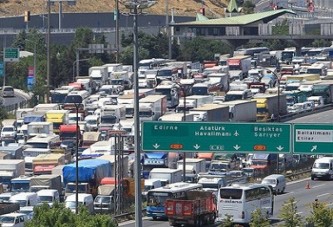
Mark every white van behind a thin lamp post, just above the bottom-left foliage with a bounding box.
[65,193,94,214]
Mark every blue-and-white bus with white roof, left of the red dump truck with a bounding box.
[147,182,202,220]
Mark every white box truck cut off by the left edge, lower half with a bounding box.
[0,159,25,190]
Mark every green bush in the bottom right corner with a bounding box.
[306,201,333,227]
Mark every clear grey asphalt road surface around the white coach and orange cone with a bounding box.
[119,178,333,227]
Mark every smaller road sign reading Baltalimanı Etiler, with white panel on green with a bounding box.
[293,123,333,154]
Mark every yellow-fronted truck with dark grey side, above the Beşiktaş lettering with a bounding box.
[253,94,287,122]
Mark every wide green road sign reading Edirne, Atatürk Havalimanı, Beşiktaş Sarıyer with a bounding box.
[142,121,291,153]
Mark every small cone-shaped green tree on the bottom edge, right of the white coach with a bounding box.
[279,197,302,227]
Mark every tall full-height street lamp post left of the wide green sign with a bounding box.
[124,0,156,227]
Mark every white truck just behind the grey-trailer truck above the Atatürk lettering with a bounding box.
[176,95,213,113]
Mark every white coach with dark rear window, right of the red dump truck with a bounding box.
[217,184,274,224]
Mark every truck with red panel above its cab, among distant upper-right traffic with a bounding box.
[227,55,251,81]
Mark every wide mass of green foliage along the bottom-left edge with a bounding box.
[25,203,117,227]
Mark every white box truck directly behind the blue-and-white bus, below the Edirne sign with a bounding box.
[148,168,183,186]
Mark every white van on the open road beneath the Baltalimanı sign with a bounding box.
[311,157,333,180]
